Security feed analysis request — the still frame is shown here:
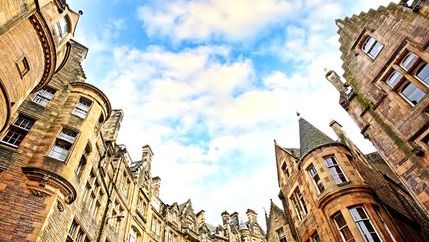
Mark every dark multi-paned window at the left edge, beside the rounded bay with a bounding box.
[2,114,34,147]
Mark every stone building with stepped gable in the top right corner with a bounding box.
[326,0,429,215]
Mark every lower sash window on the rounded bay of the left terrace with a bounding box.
[49,129,77,161]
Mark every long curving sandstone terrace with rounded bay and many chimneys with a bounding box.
[0,36,265,242]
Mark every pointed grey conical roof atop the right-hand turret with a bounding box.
[299,118,336,158]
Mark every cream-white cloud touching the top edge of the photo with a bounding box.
[139,0,293,40]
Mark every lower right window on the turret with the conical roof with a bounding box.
[349,206,381,242]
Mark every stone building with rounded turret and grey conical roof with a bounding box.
[268,118,429,242]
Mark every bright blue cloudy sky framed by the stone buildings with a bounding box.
[68,0,390,225]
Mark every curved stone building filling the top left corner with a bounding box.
[0,0,80,135]
